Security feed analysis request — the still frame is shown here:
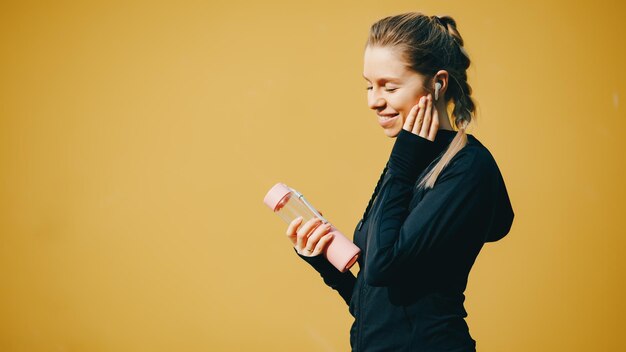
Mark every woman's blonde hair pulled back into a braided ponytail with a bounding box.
[366,12,476,188]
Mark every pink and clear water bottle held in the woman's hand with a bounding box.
[263,183,361,273]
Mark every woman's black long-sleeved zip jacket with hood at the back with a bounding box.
[300,129,514,352]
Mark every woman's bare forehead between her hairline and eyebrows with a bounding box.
[363,46,416,81]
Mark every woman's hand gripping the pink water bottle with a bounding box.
[287,216,333,257]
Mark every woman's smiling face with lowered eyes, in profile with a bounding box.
[363,46,428,137]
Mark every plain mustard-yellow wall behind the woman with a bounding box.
[0,0,626,352]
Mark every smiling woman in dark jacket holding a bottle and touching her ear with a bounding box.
[287,13,514,352]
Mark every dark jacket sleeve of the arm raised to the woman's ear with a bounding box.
[364,129,488,286]
